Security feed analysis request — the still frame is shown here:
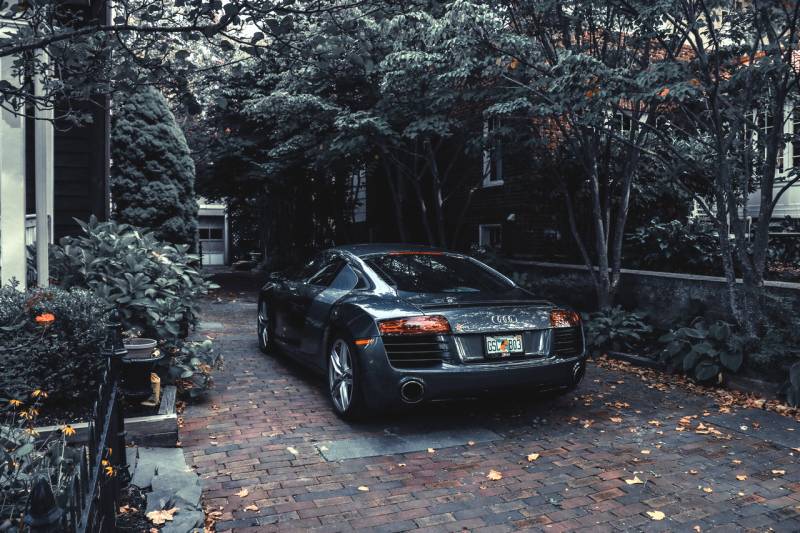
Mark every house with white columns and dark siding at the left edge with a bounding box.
[0,2,109,288]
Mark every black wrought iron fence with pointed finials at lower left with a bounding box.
[25,312,127,533]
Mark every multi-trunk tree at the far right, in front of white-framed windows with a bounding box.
[629,0,800,339]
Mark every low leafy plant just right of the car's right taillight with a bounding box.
[584,306,653,351]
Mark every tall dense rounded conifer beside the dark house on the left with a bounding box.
[111,88,197,244]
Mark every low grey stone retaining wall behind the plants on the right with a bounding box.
[508,260,800,326]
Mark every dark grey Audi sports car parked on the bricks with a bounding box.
[257,244,586,418]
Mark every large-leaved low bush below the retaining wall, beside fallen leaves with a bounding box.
[659,318,743,381]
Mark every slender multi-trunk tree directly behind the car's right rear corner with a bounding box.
[453,0,676,308]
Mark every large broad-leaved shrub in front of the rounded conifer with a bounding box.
[52,217,216,347]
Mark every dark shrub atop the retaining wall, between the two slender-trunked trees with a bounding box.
[624,219,722,274]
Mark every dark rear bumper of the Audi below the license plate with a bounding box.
[362,347,586,408]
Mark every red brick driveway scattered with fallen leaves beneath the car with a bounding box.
[181,290,800,532]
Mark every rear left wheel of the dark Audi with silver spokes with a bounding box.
[326,335,367,420]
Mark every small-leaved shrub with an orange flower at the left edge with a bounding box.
[0,285,106,401]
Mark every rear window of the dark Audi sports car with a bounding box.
[365,253,511,293]
